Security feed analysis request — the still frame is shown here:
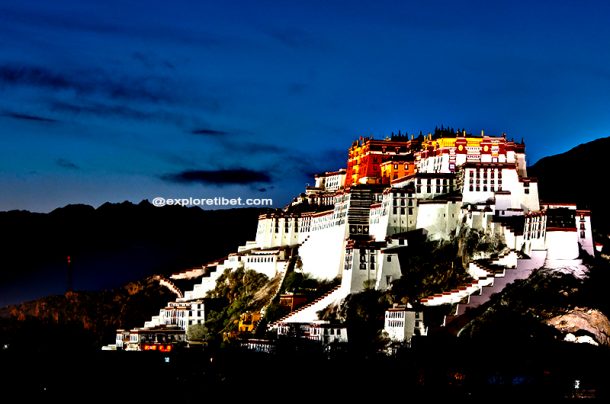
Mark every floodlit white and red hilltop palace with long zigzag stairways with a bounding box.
[105,132,594,349]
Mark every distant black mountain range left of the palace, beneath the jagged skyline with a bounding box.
[0,201,263,307]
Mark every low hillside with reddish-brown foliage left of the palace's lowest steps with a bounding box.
[0,277,175,352]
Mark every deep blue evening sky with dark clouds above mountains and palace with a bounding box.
[0,0,610,212]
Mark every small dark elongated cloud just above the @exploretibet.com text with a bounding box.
[161,168,271,186]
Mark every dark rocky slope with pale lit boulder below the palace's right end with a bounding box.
[460,257,610,347]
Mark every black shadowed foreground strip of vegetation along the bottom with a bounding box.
[0,338,610,403]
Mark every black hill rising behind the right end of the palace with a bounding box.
[528,137,610,234]
